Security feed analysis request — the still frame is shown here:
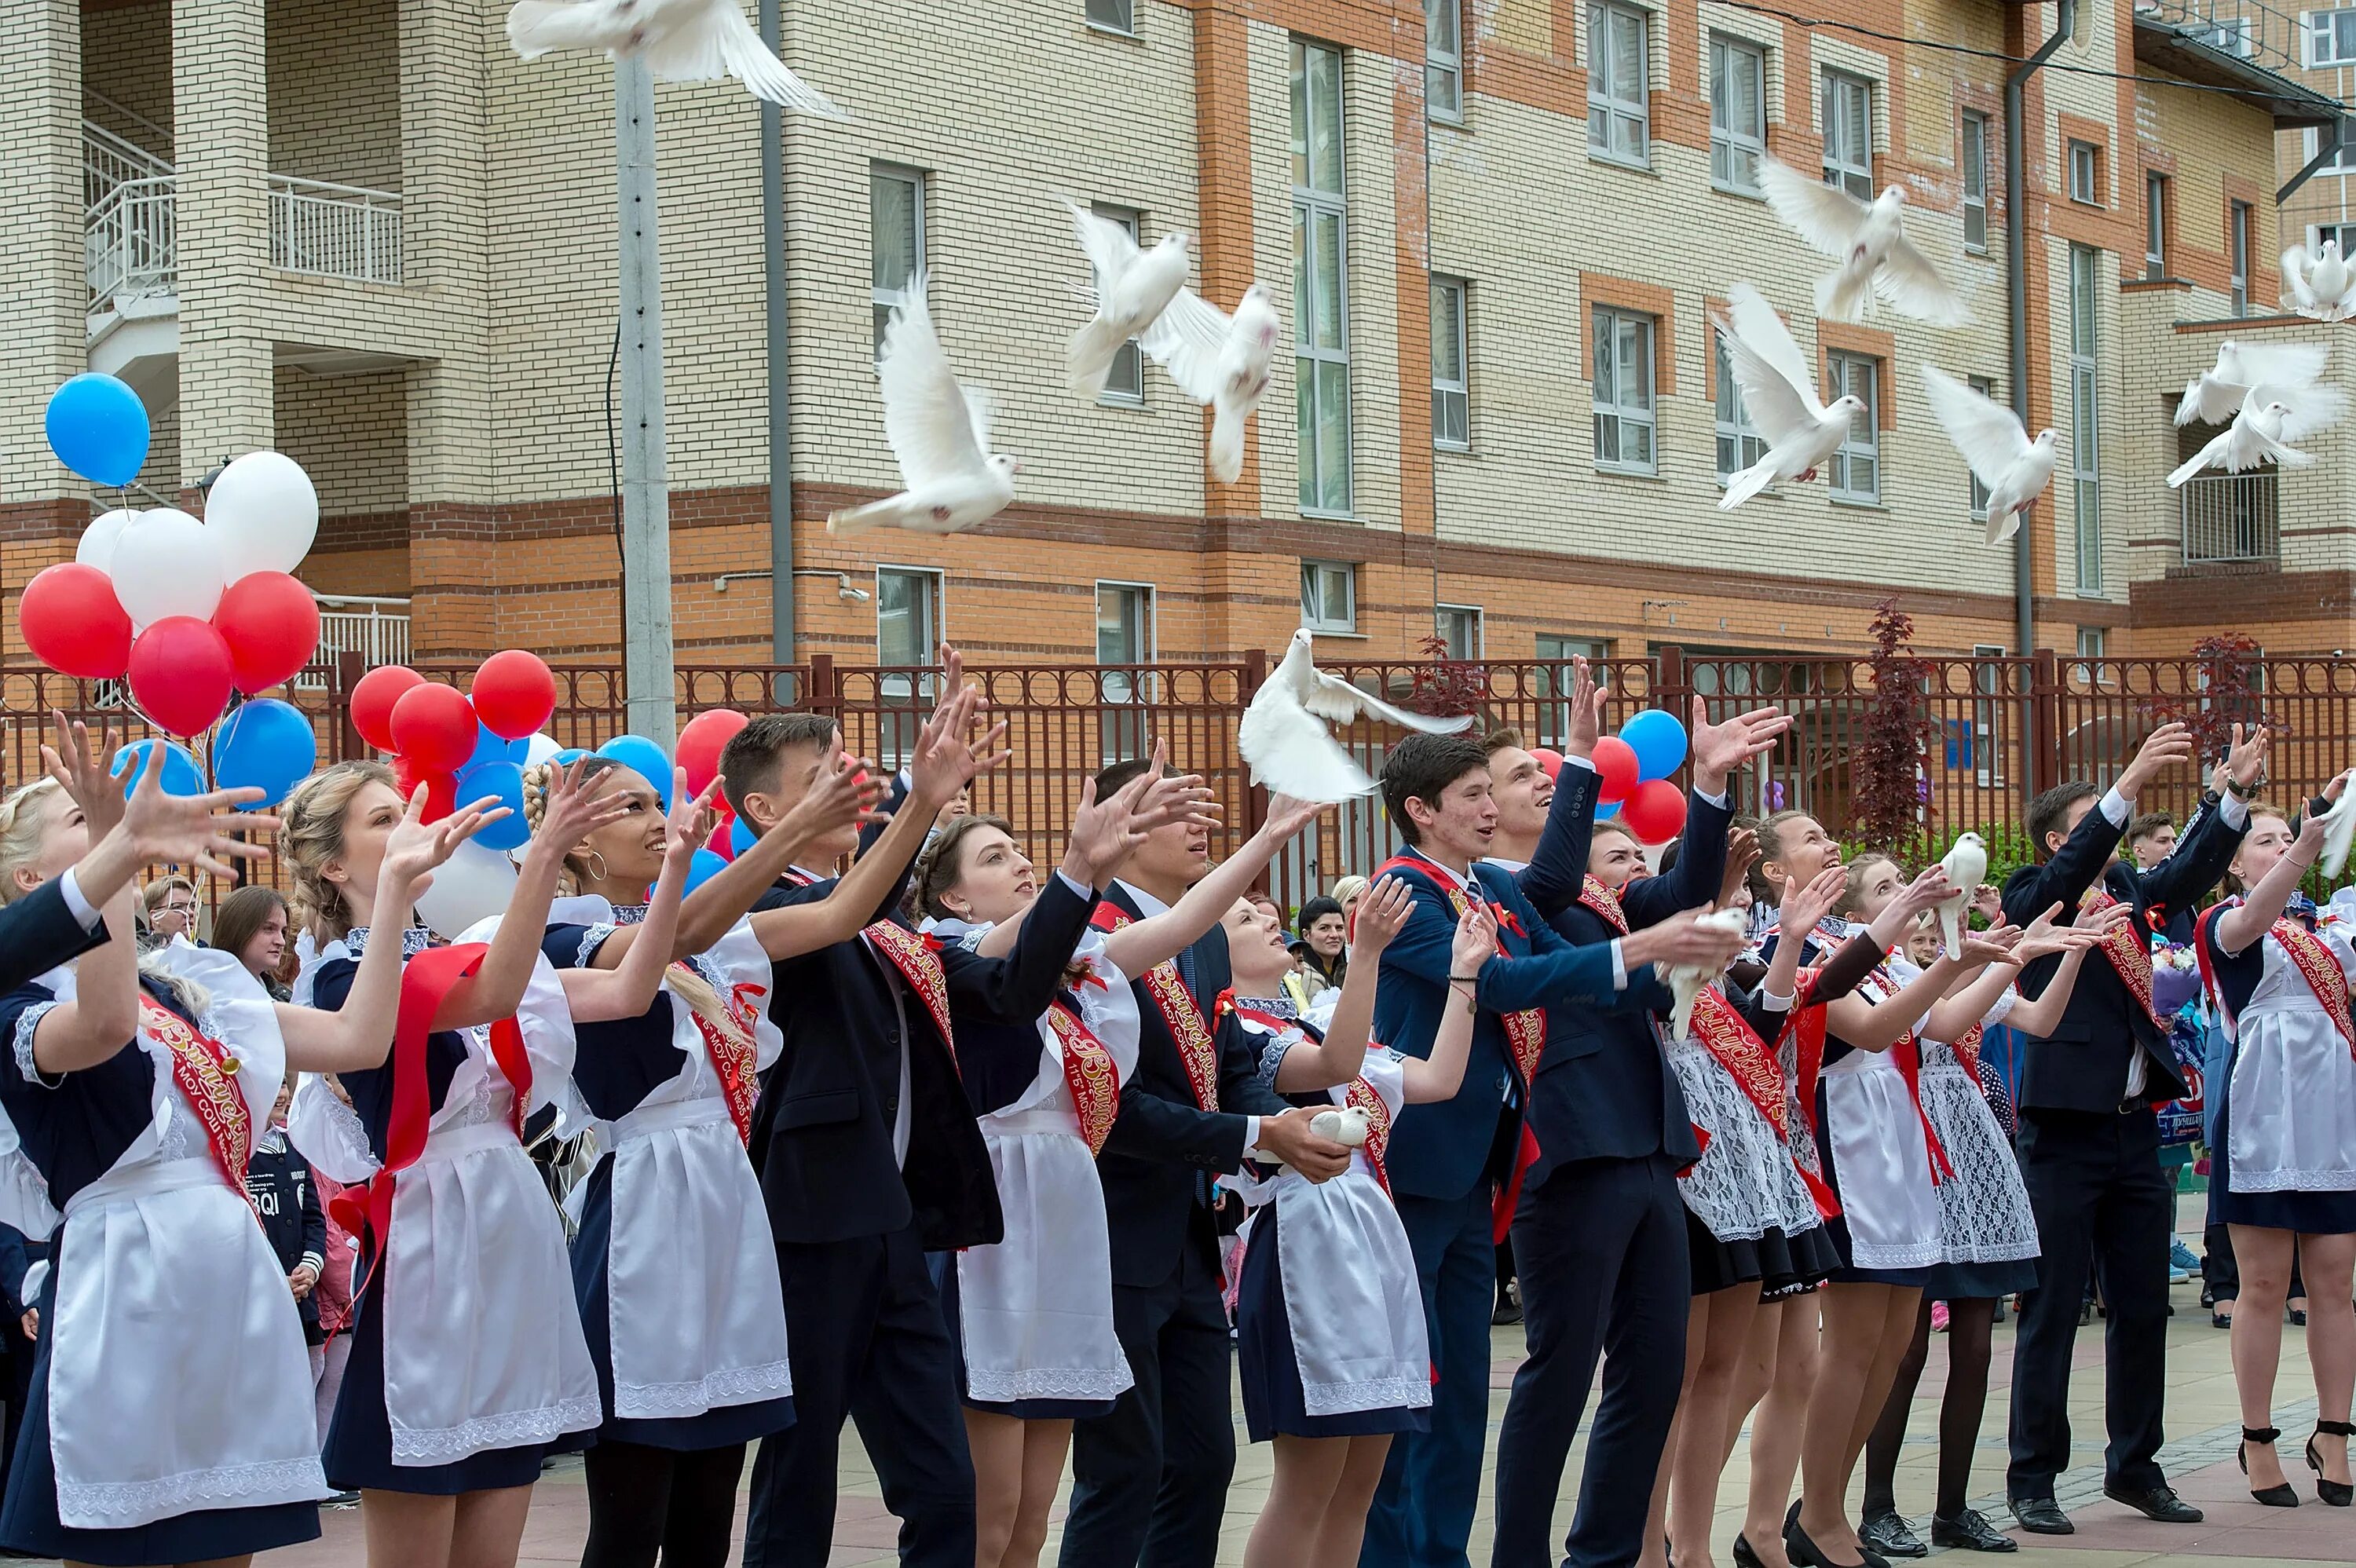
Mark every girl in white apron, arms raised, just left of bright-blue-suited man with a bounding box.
[1216,878,1496,1568]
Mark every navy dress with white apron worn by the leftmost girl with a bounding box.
[0,948,327,1566]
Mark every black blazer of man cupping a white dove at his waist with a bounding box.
[1096,885,1291,1288]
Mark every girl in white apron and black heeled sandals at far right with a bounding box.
[2196,777,2356,1507]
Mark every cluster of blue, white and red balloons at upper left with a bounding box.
[16,375,318,735]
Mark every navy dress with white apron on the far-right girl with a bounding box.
[2198,904,2356,1236]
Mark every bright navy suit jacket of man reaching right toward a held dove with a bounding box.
[1374,854,1649,1198]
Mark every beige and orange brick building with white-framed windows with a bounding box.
[0,0,2356,664]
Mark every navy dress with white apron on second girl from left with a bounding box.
[287,925,601,1497]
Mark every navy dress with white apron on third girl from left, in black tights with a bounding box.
[540,897,794,1450]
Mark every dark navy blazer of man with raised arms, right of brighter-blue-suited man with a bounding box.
[1522,763,1732,1184]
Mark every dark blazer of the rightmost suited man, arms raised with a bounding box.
[2005,781,2250,1111]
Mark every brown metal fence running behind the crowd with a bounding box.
[0,648,2356,906]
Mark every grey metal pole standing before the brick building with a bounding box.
[613,57,679,751]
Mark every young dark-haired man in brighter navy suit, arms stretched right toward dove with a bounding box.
[1359,735,1739,1568]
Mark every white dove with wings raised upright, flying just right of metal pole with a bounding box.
[827,273,1023,535]
